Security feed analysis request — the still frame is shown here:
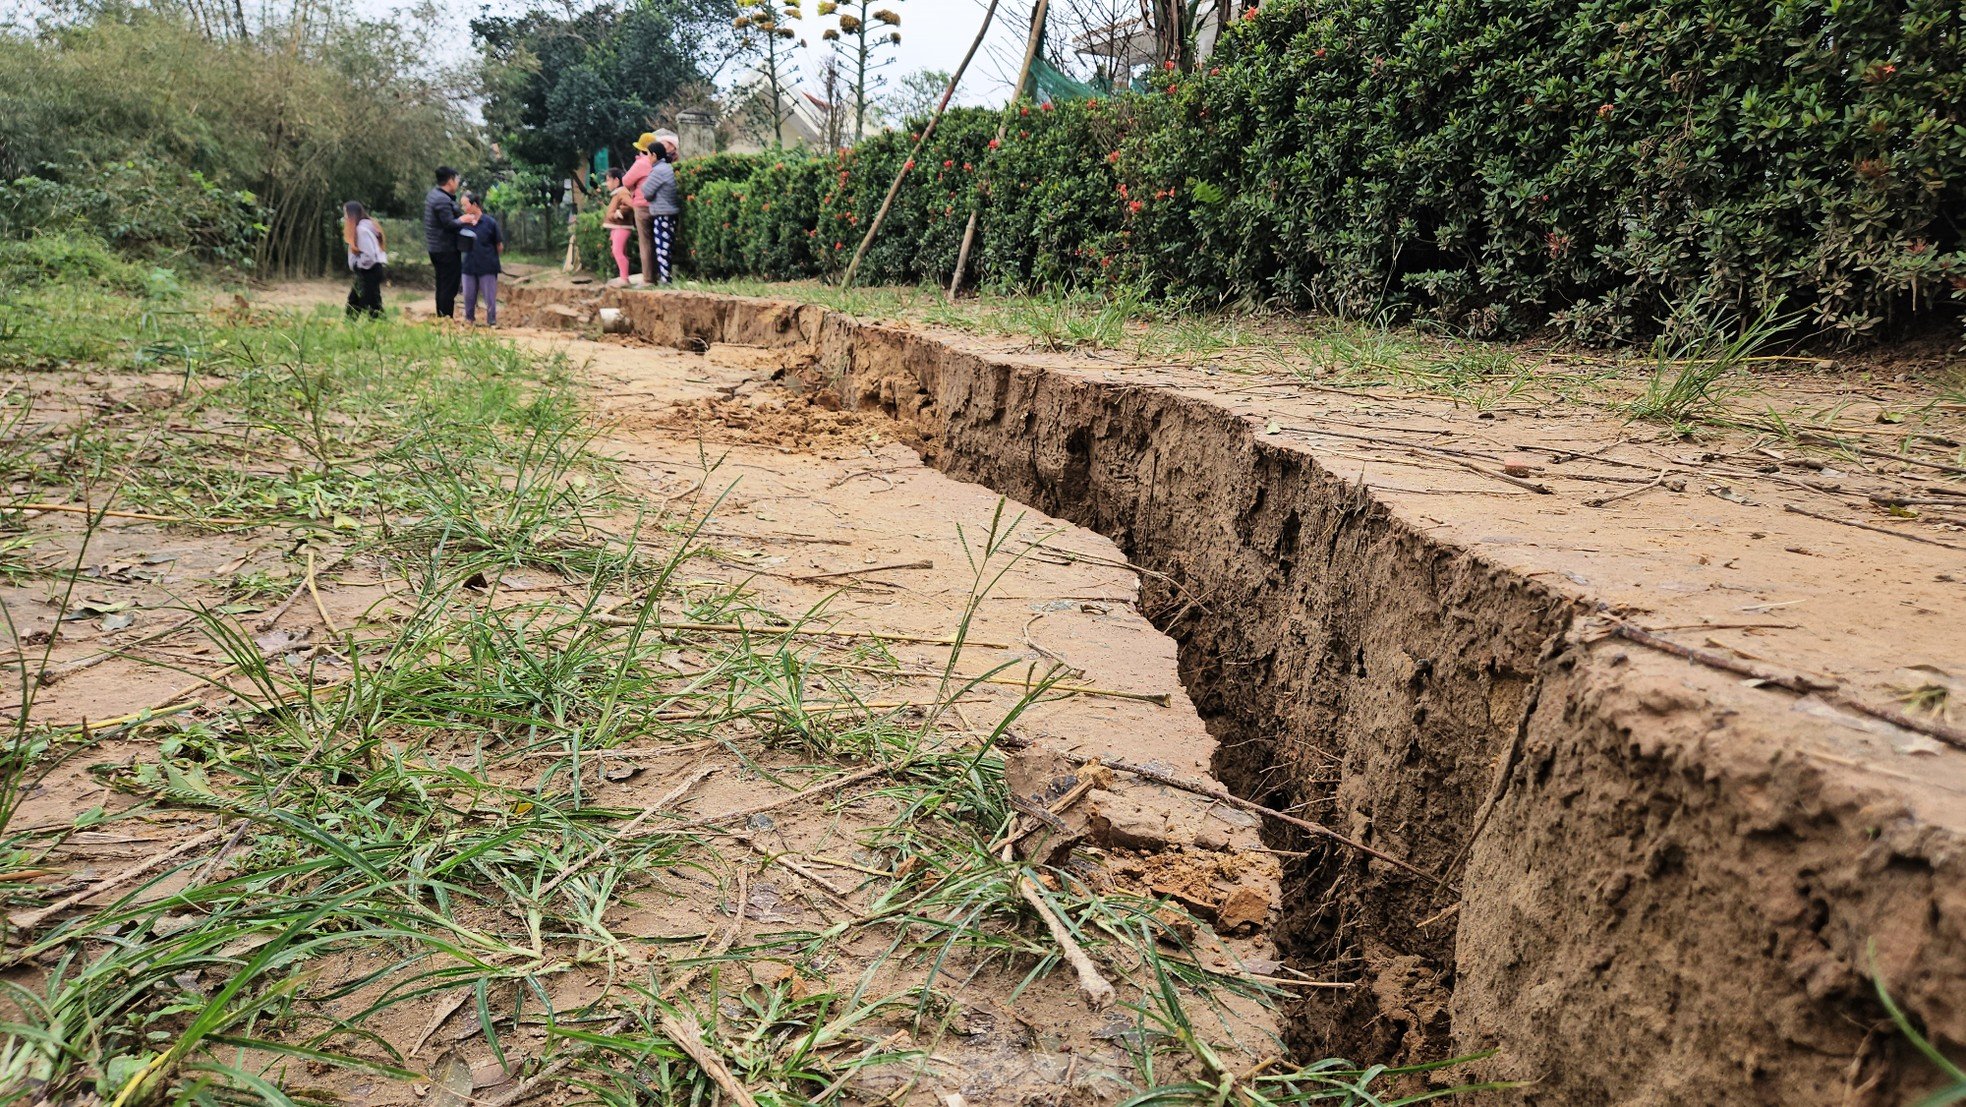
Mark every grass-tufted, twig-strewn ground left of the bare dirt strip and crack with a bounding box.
[0,253,1502,1107]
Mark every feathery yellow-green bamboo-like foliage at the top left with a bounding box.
[0,0,472,269]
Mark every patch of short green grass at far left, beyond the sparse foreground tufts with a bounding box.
[0,273,611,564]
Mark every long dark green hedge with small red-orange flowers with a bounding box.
[589,0,1966,340]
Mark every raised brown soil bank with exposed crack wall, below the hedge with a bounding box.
[507,287,1966,1103]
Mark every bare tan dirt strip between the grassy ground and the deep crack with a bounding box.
[450,328,1280,1103]
